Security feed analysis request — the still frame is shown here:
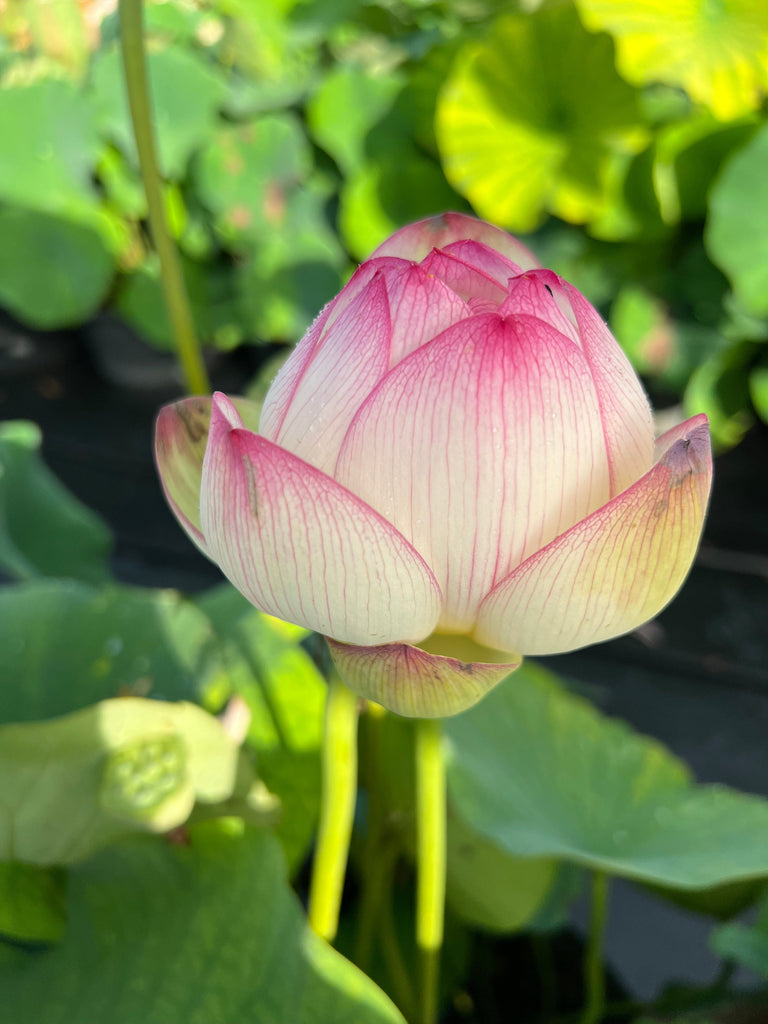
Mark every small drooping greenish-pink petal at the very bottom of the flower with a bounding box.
[328,640,521,718]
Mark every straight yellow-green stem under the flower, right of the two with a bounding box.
[416,719,446,1024]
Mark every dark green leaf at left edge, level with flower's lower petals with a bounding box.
[0,421,112,583]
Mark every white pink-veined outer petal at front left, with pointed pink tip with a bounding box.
[201,395,440,644]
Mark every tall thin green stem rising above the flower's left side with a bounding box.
[119,0,211,394]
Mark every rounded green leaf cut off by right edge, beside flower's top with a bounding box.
[705,125,768,316]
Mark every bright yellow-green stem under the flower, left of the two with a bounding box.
[309,676,358,942]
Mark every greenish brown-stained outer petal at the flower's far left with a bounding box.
[155,396,259,555]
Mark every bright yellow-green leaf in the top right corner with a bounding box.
[575,0,768,121]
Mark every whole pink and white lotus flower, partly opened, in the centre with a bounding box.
[157,214,712,716]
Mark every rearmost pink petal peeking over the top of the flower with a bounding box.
[373,213,540,270]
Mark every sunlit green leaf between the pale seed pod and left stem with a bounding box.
[197,584,326,868]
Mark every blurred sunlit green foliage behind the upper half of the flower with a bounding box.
[0,0,768,449]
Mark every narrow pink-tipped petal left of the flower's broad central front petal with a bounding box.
[262,274,393,472]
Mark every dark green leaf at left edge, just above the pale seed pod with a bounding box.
[0,580,211,722]
